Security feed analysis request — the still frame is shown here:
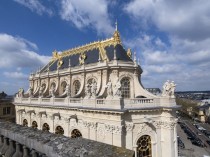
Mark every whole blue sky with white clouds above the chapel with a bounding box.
[0,0,210,94]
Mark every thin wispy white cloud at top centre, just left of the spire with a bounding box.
[60,0,114,35]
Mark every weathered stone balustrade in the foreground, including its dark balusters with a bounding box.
[0,121,134,157]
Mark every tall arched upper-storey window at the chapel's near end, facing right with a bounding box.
[120,77,130,98]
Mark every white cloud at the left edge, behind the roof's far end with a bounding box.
[0,34,50,94]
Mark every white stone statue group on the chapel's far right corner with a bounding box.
[162,80,176,98]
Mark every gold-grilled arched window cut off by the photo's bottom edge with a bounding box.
[137,135,152,157]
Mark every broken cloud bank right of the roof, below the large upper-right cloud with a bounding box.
[125,34,210,90]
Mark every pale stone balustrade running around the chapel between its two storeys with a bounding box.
[14,97,176,109]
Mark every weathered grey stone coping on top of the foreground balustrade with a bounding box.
[0,121,134,157]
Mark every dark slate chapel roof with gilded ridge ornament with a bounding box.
[41,32,132,72]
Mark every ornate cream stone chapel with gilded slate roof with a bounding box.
[14,27,178,157]
